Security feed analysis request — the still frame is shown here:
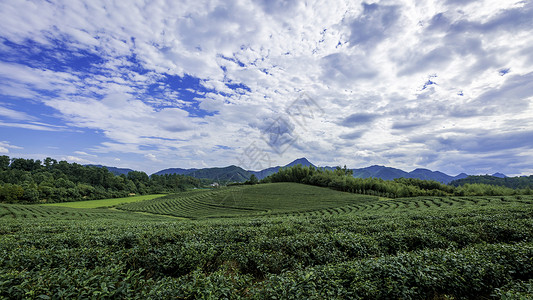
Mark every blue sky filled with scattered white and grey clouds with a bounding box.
[0,0,533,176]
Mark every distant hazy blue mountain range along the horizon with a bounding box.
[93,157,507,184]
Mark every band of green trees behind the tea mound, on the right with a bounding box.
[261,165,533,198]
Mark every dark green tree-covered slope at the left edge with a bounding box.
[0,156,202,203]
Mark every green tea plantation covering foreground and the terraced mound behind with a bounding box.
[0,183,533,299]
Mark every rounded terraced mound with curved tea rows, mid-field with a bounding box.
[118,182,379,218]
